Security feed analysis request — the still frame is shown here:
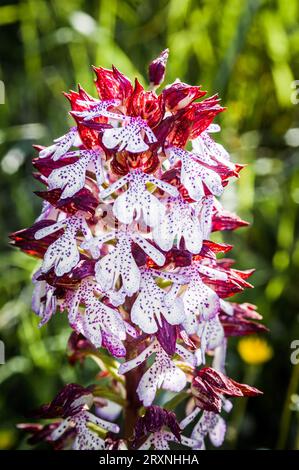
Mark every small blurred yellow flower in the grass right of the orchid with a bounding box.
[238,337,273,365]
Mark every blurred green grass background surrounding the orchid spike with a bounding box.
[0,0,299,449]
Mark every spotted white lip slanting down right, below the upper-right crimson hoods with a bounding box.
[167,147,223,201]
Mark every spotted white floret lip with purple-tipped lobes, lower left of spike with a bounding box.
[66,278,126,357]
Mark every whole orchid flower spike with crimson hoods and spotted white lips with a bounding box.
[11,50,265,449]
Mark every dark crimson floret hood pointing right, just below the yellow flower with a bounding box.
[191,367,262,413]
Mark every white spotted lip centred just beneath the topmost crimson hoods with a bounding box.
[102,117,157,153]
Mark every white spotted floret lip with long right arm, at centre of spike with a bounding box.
[92,230,165,296]
